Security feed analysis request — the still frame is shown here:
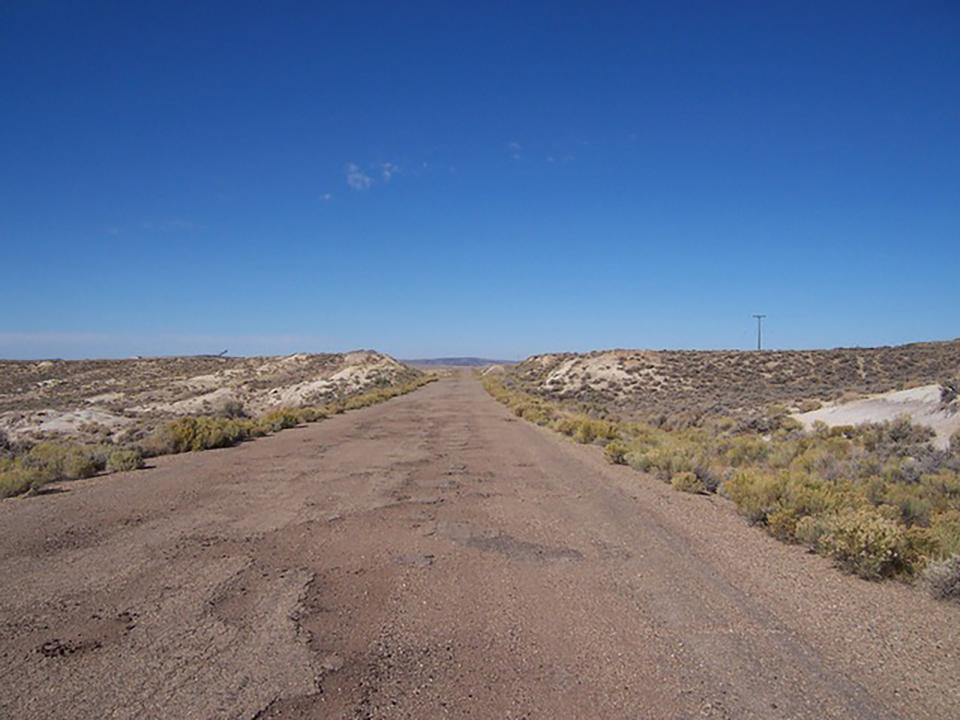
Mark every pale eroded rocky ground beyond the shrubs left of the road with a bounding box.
[0,350,421,440]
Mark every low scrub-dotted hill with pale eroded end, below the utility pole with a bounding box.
[509,340,960,420]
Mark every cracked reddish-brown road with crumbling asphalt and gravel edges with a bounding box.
[0,374,960,720]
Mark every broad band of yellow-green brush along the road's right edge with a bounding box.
[484,376,960,601]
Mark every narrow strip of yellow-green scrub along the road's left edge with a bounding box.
[0,375,436,498]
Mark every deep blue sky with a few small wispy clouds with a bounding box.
[0,0,960,358]
